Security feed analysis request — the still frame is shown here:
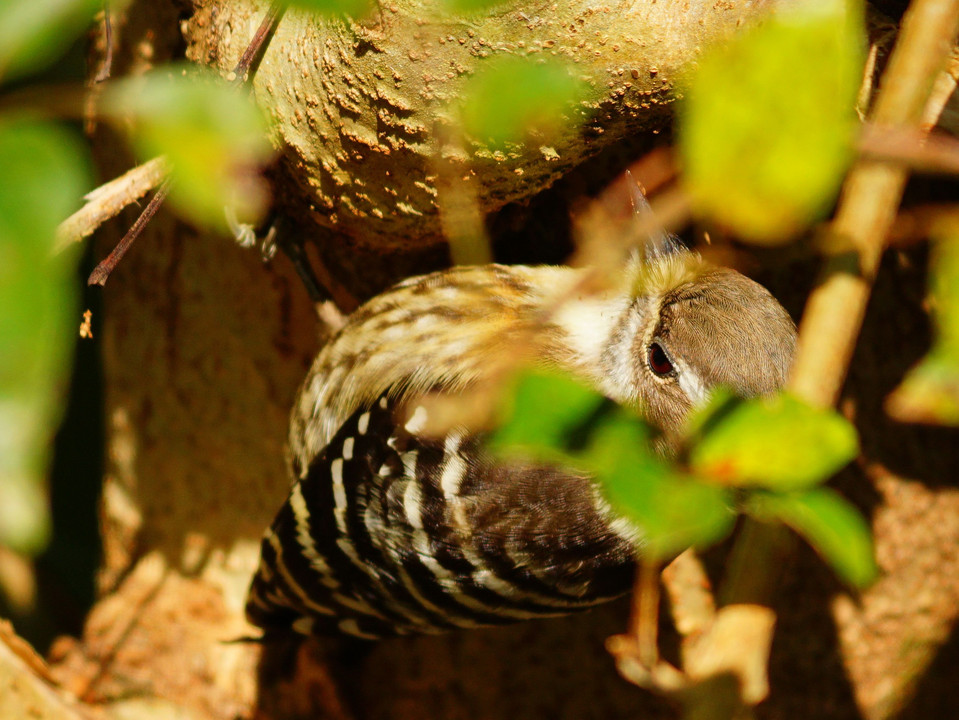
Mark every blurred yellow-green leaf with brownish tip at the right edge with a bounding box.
[887,226,959,425]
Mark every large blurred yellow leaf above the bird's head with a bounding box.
[679,0,865,243]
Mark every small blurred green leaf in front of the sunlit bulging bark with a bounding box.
[461,57,586,152]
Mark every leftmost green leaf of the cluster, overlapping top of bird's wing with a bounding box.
[489,370,607,459]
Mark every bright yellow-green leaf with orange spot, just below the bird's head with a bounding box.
[689,394,858,490]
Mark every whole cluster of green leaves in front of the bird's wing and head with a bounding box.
[492,371,876,586]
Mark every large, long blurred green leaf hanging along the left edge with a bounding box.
[0,118,90,553]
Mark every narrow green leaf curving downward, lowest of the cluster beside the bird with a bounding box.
[747,488,879,588]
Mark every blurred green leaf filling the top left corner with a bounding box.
[0,0,103,79]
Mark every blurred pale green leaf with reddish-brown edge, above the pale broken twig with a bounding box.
[104,66,271,228]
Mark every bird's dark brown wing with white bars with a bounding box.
[247,395,633,639]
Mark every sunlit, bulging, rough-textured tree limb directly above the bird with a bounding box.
[184,0,788,296]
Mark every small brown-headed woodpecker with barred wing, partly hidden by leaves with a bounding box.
[247,251,795,638]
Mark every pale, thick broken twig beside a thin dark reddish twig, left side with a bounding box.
[54,157,169,252]
